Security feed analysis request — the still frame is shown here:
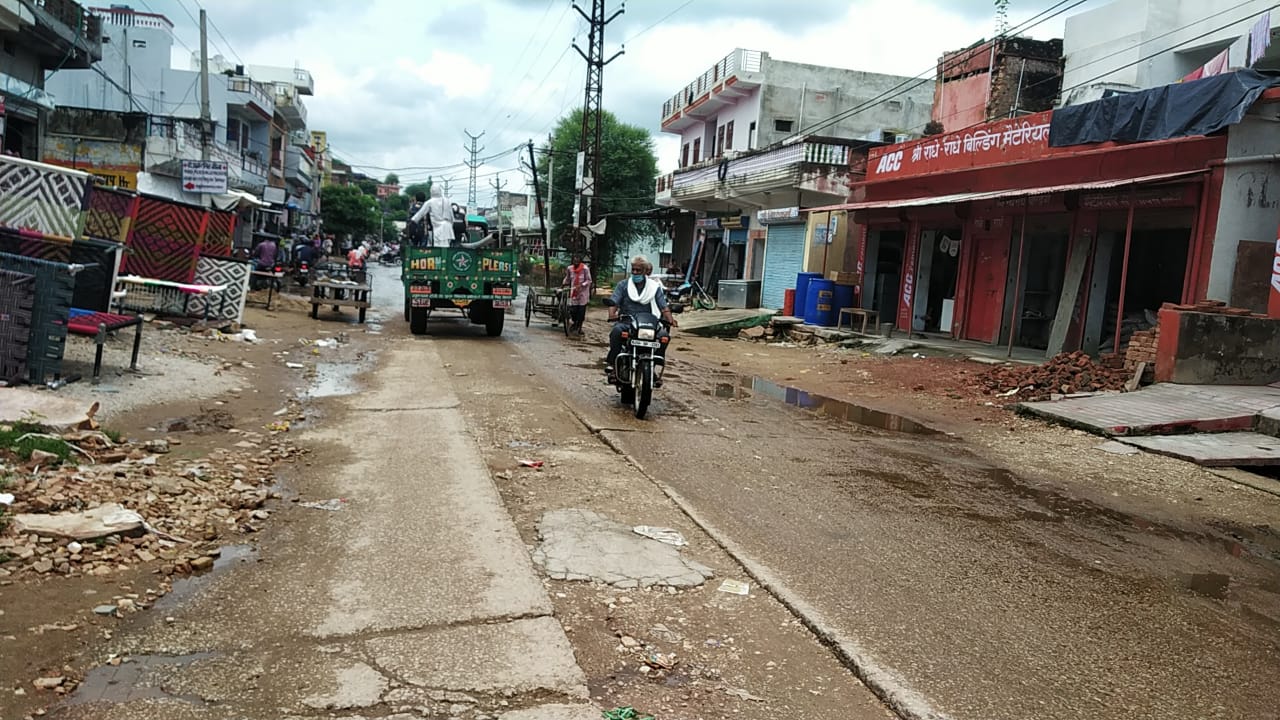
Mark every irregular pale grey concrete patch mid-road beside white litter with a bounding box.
[534,510,713,588]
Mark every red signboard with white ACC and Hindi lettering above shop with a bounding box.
[867,110,1053,182]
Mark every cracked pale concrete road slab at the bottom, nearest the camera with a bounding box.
[364,609,588,700]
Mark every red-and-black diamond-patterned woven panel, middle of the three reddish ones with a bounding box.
[124,196,207,283]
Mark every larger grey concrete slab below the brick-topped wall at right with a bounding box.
[1018,383,1280,436]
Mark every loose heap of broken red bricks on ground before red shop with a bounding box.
[979,351,1130,402]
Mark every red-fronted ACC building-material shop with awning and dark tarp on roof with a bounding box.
[826,70,1280,354]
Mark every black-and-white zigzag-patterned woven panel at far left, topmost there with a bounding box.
[0,156,90,242]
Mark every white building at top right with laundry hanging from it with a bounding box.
[1062,0,1280,105]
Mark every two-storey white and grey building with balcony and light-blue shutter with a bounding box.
[655,49,933,307]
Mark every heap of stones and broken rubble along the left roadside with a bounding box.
[0,429,302,578]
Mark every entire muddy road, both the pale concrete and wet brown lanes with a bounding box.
[45,262,1280,720]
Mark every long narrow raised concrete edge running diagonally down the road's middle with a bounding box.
[562,401,951,720]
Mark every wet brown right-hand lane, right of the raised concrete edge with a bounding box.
[465,284,1280,720]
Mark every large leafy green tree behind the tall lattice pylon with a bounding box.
[538,109,658,269]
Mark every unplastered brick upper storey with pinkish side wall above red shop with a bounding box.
[933,37,1062,132]
